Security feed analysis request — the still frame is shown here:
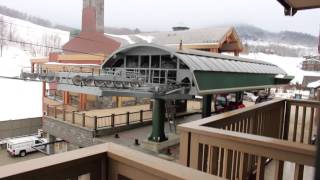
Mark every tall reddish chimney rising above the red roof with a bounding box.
[82,0,104,33]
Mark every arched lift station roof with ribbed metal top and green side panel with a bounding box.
[102,44,292,95]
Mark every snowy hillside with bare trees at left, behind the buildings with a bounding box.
[0,15,69,121]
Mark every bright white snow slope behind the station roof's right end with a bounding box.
[240,53,320,84]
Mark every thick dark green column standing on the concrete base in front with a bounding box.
[149,99,167,142]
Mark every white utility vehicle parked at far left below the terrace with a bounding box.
[7,136,47,157]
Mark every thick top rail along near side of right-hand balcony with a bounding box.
[180,126,316,166]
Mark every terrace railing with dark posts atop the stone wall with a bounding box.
[46,105,152,130]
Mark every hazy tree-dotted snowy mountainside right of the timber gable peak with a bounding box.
[236,25,318,57]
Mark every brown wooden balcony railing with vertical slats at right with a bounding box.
[179,100,320,179]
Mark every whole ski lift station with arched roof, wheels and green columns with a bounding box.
[21,44,292,145]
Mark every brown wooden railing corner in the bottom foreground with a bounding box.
[0,143,221,180]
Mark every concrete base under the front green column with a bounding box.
[142,134,180,153]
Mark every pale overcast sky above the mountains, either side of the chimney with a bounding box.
[0,0,320,35]
